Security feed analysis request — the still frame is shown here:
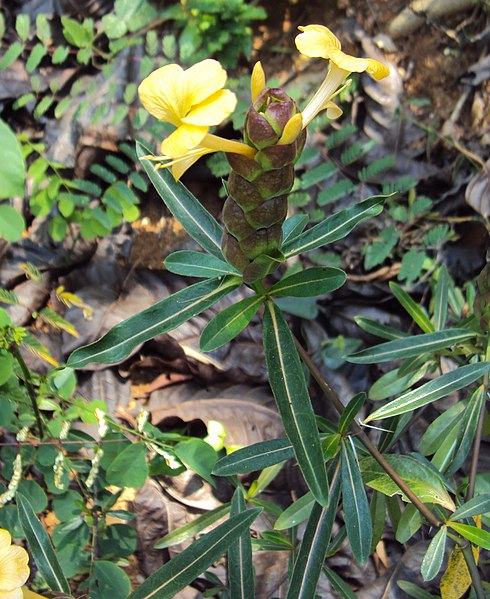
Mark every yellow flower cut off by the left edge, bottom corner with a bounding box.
[0,529,29,599]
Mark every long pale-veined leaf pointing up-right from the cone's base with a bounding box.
[282,196,388,258]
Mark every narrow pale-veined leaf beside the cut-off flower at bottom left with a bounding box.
[16,493,71,595]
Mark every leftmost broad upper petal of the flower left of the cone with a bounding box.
[138,64,192,126]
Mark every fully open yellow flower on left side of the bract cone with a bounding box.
[138,59,253,179]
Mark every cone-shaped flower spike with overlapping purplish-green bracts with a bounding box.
[222,88,306,283]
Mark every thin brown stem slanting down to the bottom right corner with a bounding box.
[293,334,490,599]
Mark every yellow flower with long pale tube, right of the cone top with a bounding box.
[296,25,390,127]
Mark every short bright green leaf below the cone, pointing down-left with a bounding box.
[200,295,265,352]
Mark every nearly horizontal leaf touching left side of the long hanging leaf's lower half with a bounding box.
[213,438,294,476]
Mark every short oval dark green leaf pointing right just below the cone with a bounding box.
[268,267,347,297]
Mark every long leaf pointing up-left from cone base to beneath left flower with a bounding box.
[136,143,223,260]
